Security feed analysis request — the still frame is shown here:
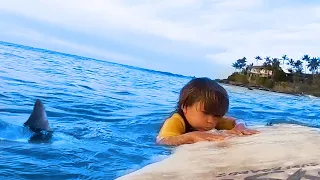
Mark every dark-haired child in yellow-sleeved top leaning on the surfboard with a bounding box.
[157,78,258,145]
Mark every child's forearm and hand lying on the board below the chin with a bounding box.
[185,131,229,143]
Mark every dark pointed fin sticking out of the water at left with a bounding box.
[23,99,53,141]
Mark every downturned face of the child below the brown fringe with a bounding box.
[183,103,218,131]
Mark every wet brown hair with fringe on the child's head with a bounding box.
[176,77,229,117]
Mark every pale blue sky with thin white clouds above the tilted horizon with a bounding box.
[0,0,320,78]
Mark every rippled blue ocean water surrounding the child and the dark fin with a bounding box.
[0,42,320,179]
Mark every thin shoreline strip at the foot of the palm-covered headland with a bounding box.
[216,79,320,97]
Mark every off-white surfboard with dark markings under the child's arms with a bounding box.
[118,124,320,180]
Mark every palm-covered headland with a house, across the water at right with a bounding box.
[223,54,320,96]
